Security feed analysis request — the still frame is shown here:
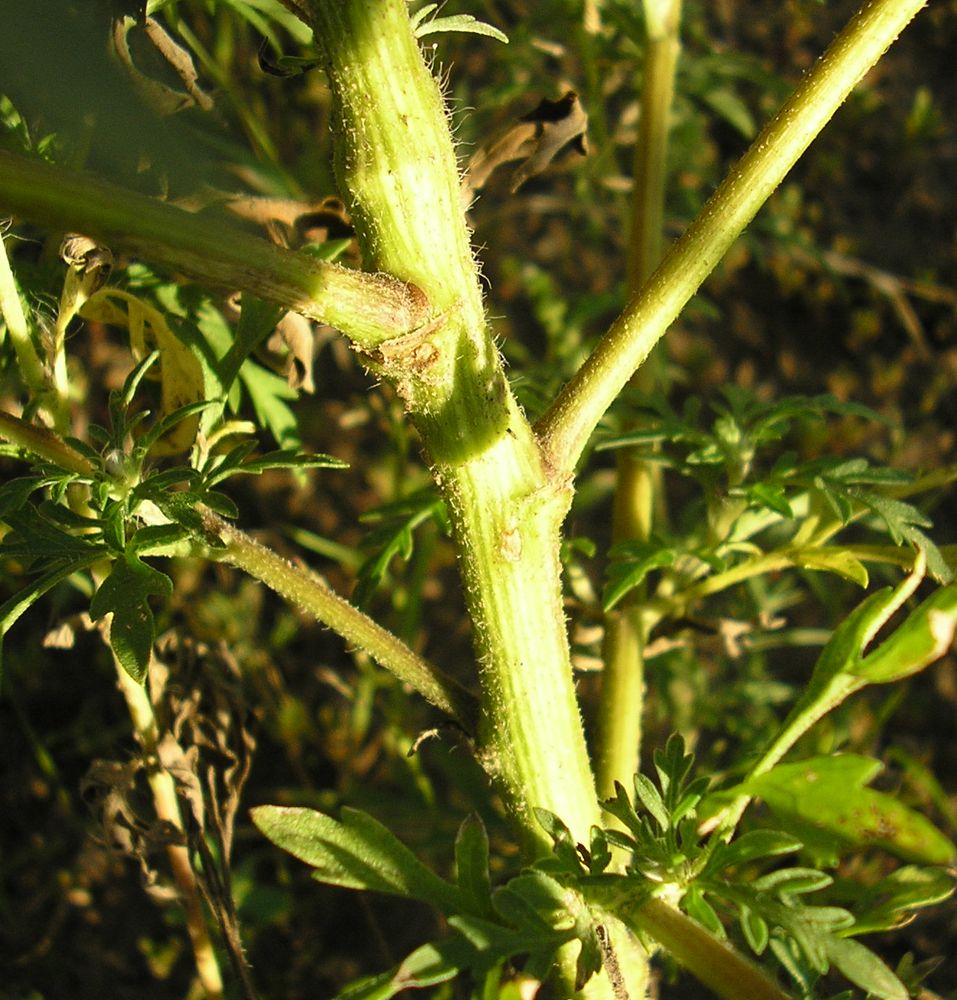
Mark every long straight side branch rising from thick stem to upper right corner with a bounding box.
[537,0,925,471]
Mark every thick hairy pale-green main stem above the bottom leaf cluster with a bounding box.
[298,0,599,857]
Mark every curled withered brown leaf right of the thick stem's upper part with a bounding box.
[462,90,588,200]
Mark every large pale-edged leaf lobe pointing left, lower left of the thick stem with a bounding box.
[252,806,467,913]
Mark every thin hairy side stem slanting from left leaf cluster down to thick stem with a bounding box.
[201,508,477,733]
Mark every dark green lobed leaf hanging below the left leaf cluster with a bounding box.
[90,552,173,684]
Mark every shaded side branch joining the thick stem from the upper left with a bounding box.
[0,151,426,350]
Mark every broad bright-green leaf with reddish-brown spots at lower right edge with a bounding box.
[741,754,957,864]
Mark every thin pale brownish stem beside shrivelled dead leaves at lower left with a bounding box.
[113,644,224,1000]
